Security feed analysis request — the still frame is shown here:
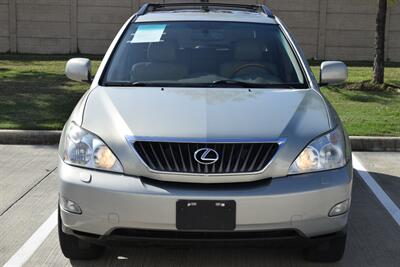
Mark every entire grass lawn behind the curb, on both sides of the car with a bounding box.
[0,55,400,136]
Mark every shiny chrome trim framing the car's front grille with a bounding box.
[125,136,287,176]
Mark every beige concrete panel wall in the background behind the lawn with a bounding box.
[0,0,400,62]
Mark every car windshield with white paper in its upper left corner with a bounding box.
[102,21,307,88]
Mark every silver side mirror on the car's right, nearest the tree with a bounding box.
[319,61,347,85]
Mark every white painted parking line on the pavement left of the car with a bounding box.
[4,210,57,267]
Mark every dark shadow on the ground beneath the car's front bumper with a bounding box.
[71,247,307,266]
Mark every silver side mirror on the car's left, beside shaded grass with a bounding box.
[65,58,92,83]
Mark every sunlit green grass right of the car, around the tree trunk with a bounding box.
[312,66,400,136]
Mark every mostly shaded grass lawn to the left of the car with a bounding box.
[0,56,100,130]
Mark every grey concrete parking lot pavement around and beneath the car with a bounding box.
[0,146,400,266]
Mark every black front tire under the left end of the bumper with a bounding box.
[58,208,105,260]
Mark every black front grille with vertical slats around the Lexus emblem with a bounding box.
[134,141,278,174]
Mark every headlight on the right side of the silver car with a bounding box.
[289,128,347,174]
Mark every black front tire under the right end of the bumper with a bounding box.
[304,232,347,262]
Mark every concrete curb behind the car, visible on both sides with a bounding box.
[0,130,400,152]
